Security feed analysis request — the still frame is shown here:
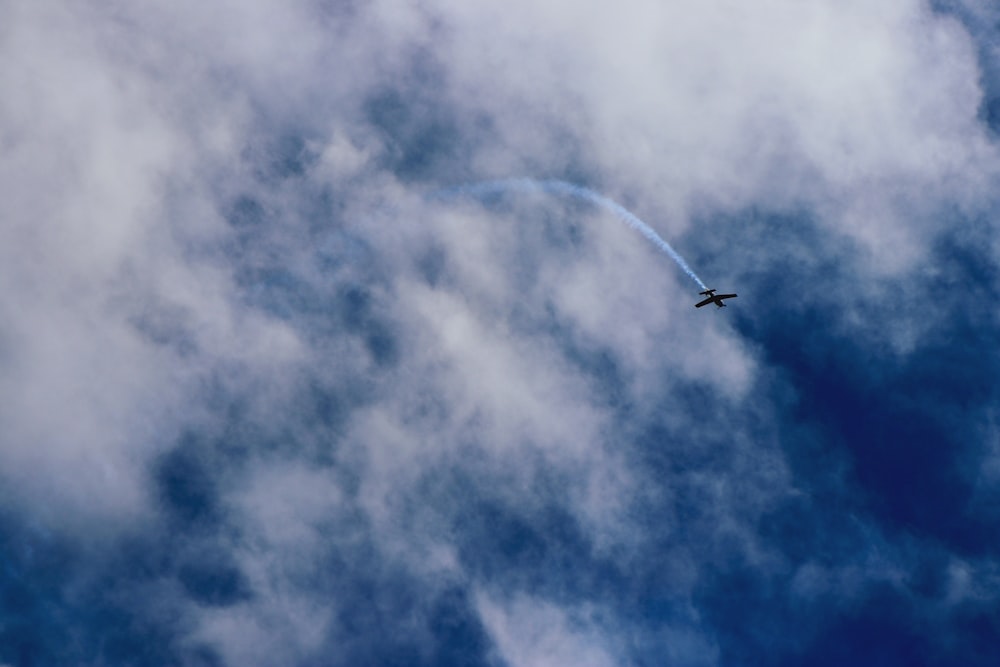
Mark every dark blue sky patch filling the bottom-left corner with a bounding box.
[0,520,219,666]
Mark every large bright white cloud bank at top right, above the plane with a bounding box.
[420,0,997,272]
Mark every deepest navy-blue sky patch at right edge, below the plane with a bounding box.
[767,294,996,553]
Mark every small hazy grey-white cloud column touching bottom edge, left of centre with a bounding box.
[189,460,350,665]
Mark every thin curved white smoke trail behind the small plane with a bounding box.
[433,178,708,290]
